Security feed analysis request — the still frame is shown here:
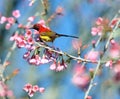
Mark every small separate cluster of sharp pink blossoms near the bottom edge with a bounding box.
[23,83,45,97]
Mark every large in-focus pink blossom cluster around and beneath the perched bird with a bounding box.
[10,20,67,71]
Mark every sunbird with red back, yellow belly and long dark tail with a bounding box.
[32,23,78,42]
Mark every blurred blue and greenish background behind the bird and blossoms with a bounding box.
[0,0,120,99]
